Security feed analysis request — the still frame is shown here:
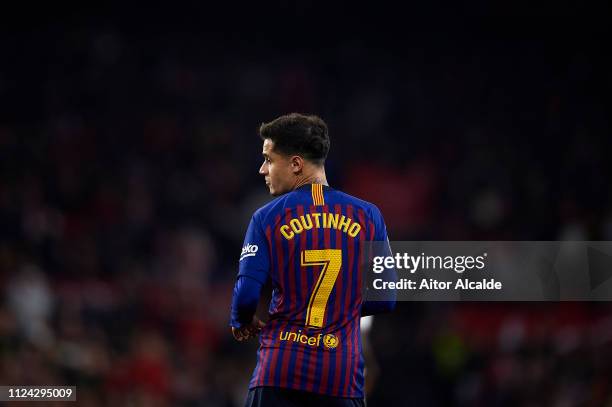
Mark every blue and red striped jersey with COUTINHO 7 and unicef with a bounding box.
[238,184,387,398]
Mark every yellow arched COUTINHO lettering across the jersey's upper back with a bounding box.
[280,212,361,240]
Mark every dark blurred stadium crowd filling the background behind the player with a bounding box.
[0,11,612,406]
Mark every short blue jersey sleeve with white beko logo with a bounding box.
[238,214,270,284]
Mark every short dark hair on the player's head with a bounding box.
[259,113,329,165]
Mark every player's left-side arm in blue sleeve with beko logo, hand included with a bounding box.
[230,214,270,341]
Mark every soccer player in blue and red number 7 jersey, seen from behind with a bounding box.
[231,113,395,406]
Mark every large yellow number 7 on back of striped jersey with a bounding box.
[301,249,342,328]
